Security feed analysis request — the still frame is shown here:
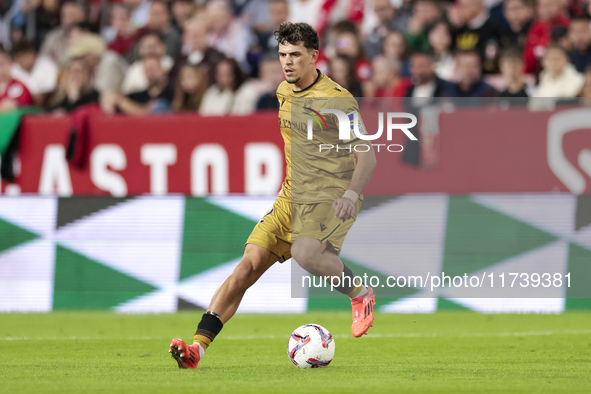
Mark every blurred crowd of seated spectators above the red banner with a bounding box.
[0,0,591,116]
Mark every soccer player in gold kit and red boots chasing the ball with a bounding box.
[169,22,376,368]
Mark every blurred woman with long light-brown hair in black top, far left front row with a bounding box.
[49,59,99,114]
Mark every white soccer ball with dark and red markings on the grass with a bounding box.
[287,324,335,368]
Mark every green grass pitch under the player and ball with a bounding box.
[0,312,591,394]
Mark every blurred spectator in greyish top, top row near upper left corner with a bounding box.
[39,1,85,68]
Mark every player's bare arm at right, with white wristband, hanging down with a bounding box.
[332,141,376,222]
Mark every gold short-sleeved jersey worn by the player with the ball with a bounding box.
[277,70,365,203]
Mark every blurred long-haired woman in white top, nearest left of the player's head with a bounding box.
[199,59,257,116]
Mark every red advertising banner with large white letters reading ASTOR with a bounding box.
[0,108,591,196]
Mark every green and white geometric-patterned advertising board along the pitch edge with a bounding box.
[0,194,591,313]
